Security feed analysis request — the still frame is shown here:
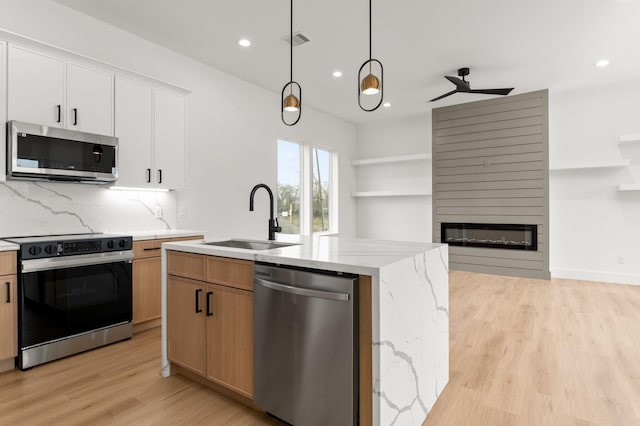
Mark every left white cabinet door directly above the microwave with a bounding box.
[8,46,65,127]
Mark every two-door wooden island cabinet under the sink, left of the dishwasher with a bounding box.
[167,251,253,399]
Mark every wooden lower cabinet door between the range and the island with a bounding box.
[133,257,162,324]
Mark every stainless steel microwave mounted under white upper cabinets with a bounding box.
[7,121,118,183]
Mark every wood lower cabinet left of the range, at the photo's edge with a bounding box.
[0,252,18,371]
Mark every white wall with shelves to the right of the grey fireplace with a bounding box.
[549,81,640,284]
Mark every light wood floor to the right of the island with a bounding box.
[425,272,640,425]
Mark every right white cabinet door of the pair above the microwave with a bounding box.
[67,63,113,136]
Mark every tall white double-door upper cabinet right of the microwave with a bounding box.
[115,77,186,189]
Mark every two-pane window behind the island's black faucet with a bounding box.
[277,140,338,235]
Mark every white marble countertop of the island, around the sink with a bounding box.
[162,236,443,276]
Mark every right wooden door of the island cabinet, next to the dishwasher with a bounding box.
[207,284,253,398]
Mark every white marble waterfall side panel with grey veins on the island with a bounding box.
[373,245,449,425]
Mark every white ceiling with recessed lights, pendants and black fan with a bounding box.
[55,0,640,123]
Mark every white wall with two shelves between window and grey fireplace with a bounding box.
[356,110,432,242]
